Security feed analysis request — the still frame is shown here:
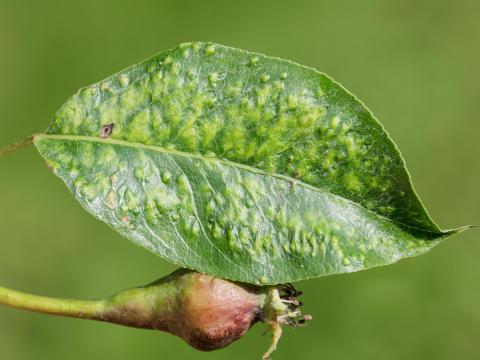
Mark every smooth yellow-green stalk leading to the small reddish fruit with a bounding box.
[0,287,107,320]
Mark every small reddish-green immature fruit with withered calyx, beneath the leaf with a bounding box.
[96,269,310,359]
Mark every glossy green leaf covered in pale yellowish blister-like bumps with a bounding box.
[34,43,468,284]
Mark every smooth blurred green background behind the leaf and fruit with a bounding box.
[0,0,480,360]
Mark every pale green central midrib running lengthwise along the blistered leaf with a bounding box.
[33,133,450,234]
